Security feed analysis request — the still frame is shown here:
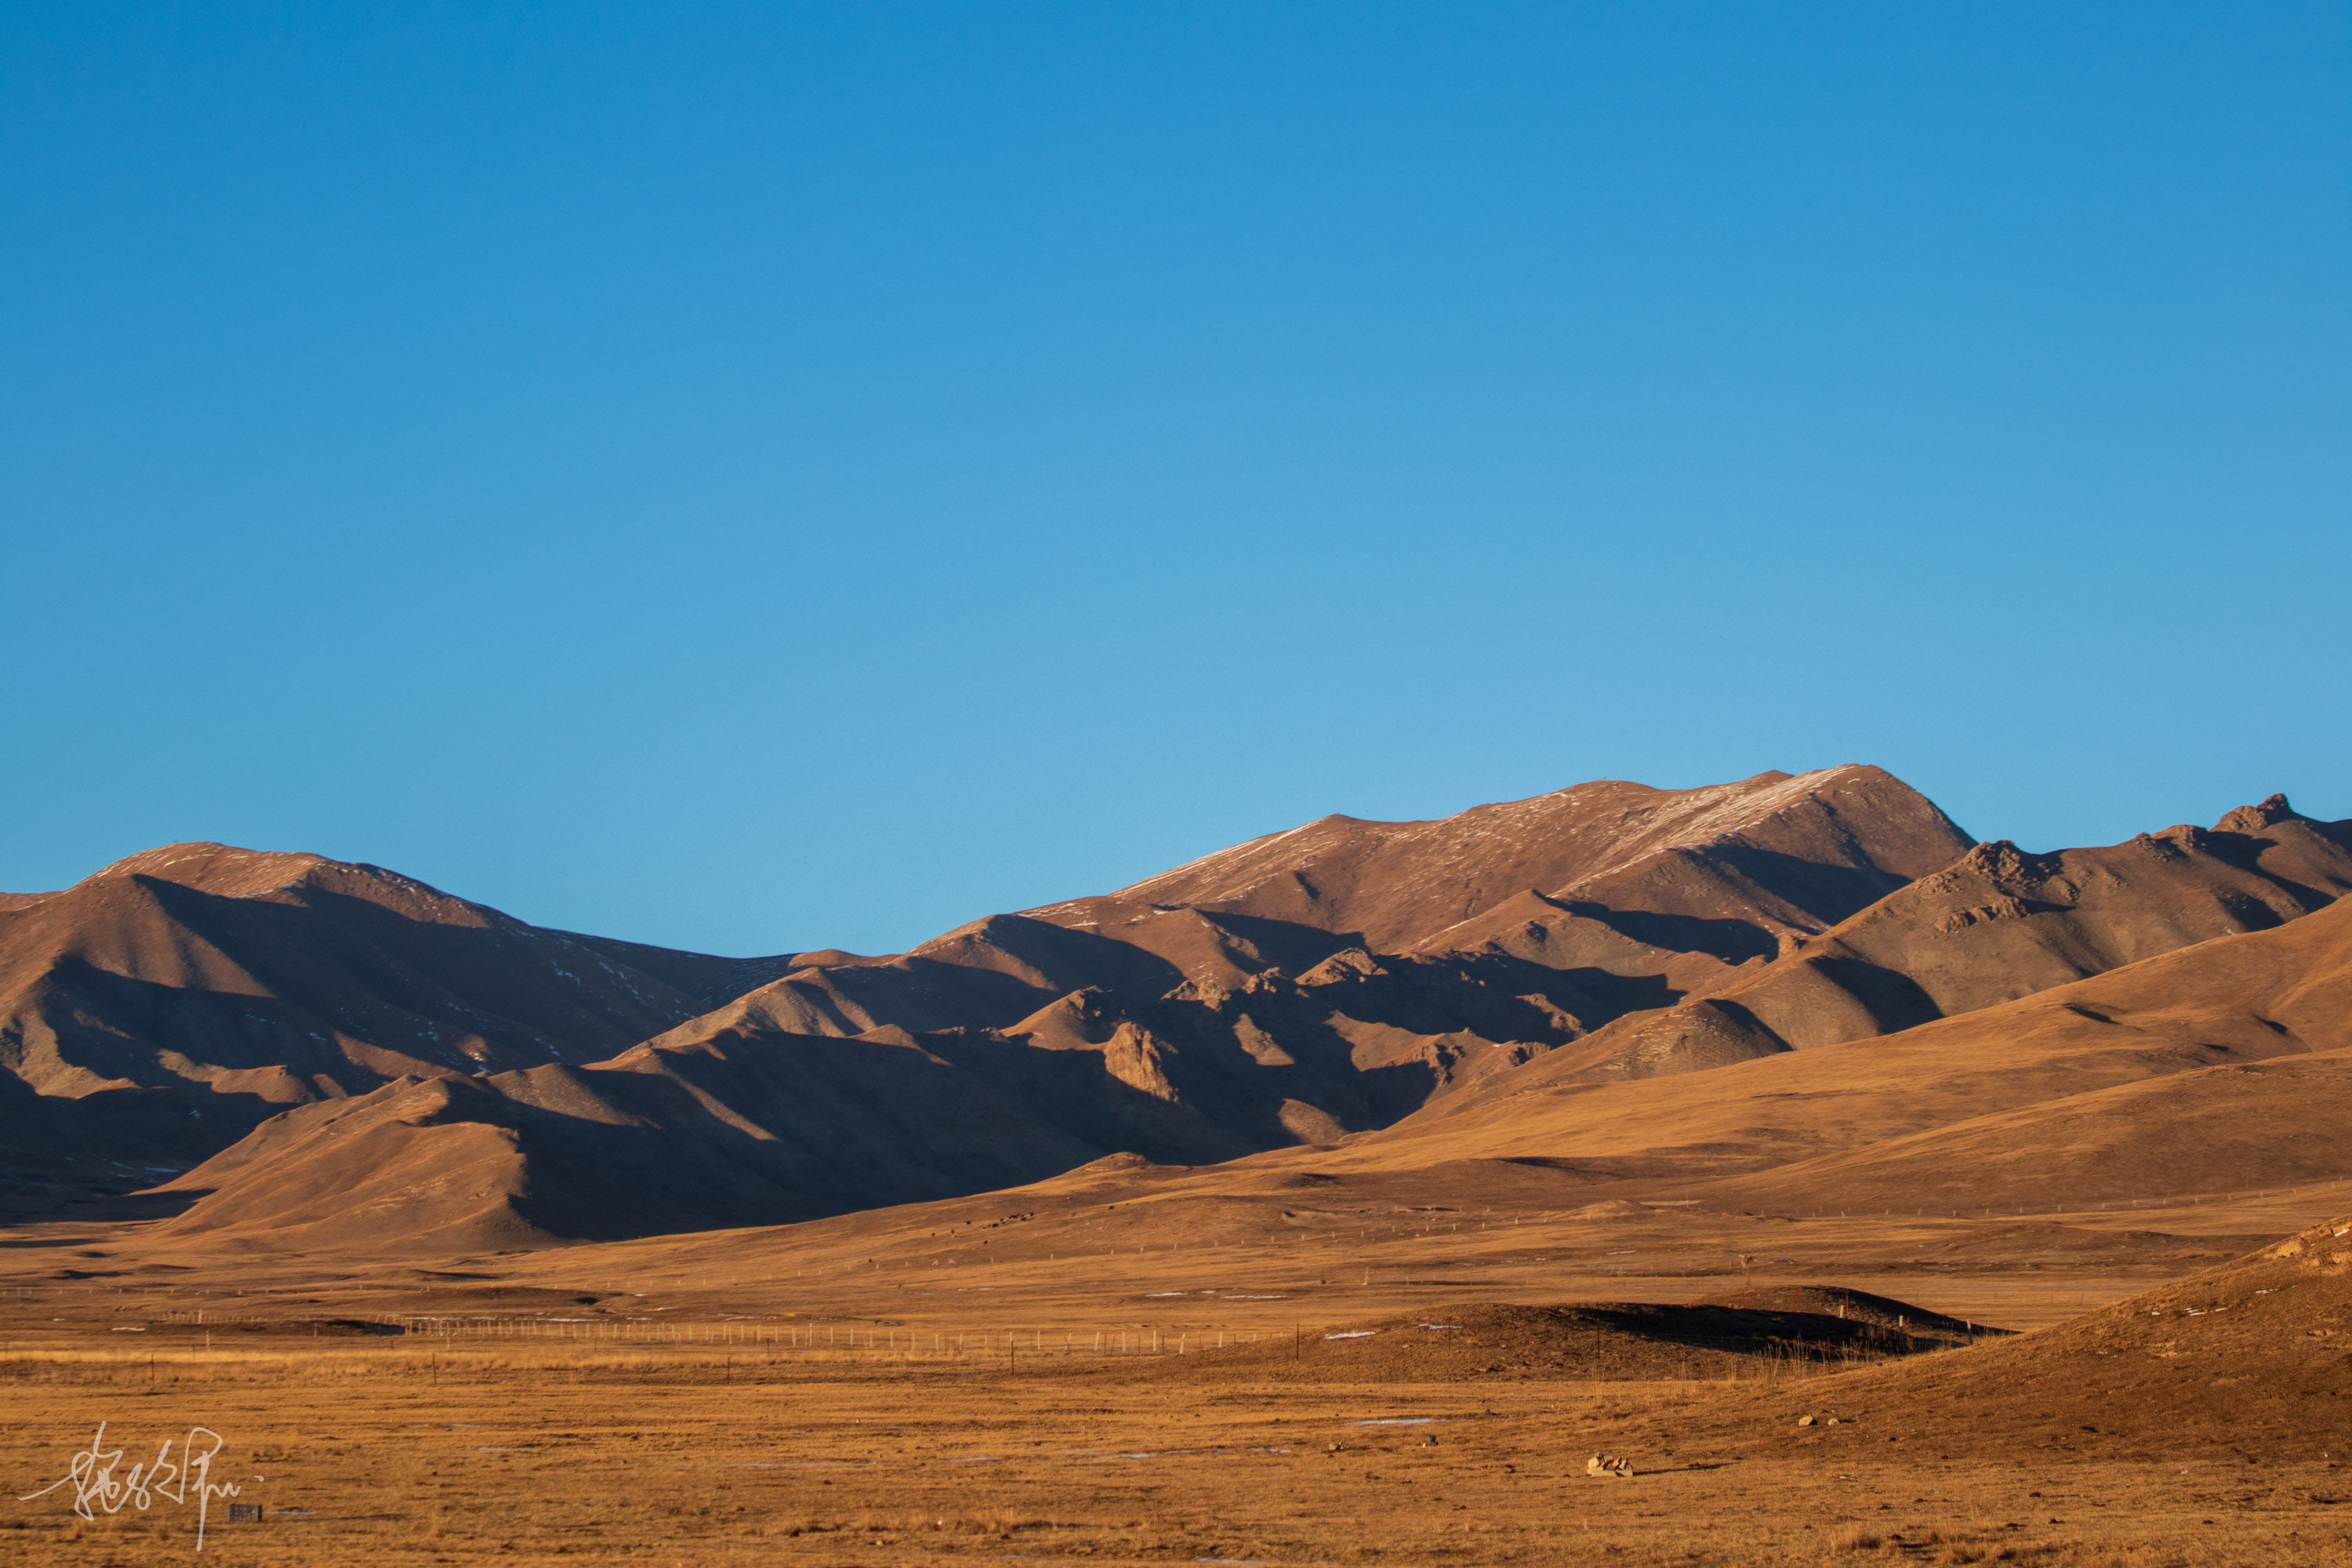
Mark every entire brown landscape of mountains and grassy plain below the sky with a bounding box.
[0,767,2352,1563]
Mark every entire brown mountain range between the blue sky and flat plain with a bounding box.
[0,767,2352,1248]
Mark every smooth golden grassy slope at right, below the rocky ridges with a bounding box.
[1319,879,2352,1210]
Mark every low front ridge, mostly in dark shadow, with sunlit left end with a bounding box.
[162,973,1581,1250]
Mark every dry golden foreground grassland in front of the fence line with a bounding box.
[0,1340,2352,1568]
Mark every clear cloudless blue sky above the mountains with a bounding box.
[0,0,2352,952]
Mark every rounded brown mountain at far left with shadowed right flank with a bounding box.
[0,844,788,1203]
